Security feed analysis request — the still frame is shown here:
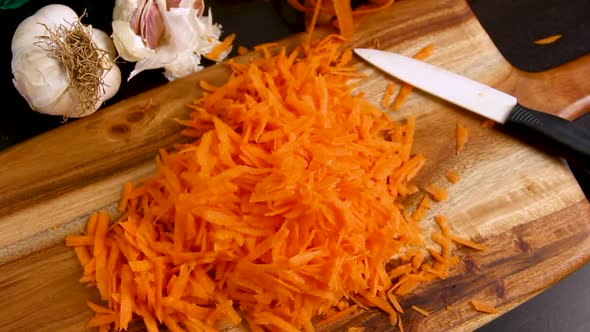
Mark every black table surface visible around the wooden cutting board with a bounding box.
[0,0,590,332]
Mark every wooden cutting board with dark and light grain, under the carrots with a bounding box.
[0,0,590,331]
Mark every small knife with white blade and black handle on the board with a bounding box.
[354,48,590,169]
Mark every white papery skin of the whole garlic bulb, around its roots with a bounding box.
[11,5,121,118]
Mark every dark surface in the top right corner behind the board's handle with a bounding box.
[468,0,590,72]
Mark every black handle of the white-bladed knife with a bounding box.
[504,104,590,169]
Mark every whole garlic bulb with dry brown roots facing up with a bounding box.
[11,5,121,117]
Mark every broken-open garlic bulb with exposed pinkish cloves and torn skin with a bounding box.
[112,0,231,80]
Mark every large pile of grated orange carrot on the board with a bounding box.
[66,3,485,331]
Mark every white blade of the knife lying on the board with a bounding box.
[354,48,517,123]
